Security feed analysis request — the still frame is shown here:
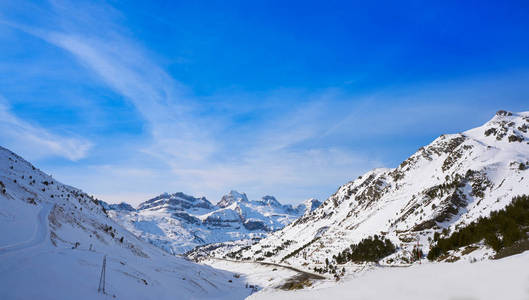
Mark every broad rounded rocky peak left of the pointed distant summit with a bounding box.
[138,192,213,210]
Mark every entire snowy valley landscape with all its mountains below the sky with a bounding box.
[0,111,529,299]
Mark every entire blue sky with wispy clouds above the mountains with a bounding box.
[0,0,529,204]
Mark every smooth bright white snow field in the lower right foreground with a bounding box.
[248,252,529,300]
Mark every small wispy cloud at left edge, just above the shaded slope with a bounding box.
[0,98,92,161]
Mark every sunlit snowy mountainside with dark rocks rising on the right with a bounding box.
[223,111,529,268]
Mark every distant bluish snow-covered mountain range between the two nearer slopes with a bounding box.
[102,191,321,254]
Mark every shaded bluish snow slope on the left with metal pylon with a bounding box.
[0,147,251,299]
